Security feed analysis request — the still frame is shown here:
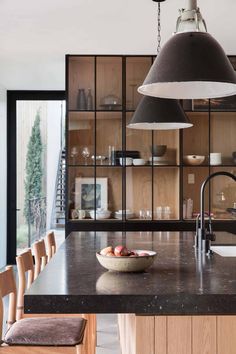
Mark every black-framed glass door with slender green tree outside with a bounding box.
[8,91,66,262]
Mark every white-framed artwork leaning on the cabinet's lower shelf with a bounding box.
[75,177,108,210]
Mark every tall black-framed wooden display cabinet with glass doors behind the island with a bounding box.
[66,55,236,232]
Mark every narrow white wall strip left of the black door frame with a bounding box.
[0,86,7,268]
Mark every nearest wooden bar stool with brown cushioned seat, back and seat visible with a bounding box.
[0,266,87,354]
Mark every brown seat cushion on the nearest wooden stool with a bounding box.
[4,317,86,346]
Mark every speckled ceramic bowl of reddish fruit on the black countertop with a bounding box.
[96,245,156,272]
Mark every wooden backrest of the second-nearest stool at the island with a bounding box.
[16,249,34,321]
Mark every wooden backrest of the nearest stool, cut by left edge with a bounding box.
[0,266,16,339]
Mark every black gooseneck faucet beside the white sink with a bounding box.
[196,171,236,254]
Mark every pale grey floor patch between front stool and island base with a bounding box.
[96,314,121,354]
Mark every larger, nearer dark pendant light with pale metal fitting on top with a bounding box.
[138,0,236,99]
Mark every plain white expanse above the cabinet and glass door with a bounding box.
[0,0,236,90]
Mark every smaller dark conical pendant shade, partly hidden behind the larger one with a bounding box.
[128,96,192,130]
